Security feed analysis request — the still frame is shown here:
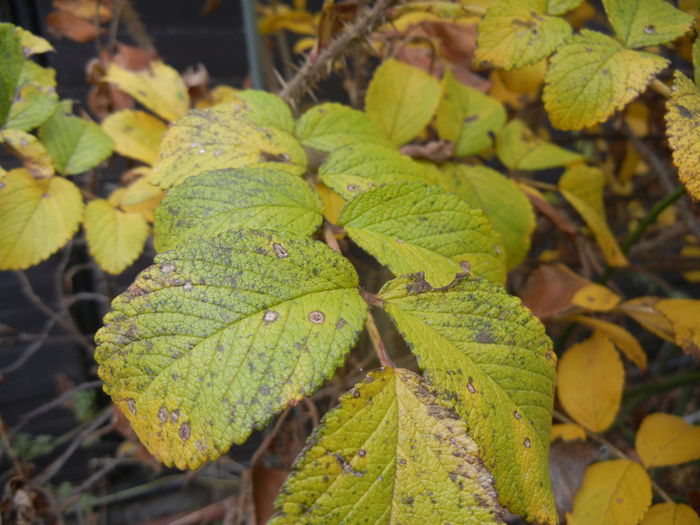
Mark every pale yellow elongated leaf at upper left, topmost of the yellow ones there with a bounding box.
[103,60,190,120]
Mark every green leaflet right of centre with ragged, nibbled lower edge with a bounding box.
[339,182,505,286]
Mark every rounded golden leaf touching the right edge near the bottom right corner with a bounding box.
[634,412,700,468]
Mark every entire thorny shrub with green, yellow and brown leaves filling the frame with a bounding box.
[0,0,700,524]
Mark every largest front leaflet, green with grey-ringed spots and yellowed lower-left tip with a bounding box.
[95,230,367,468]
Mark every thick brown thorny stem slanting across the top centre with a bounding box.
[280,0,393,107]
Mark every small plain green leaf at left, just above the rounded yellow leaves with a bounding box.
[39,111,114,175]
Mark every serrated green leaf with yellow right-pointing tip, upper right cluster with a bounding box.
[543,29,668,129]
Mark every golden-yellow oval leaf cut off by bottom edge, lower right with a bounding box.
[567,459,651,525]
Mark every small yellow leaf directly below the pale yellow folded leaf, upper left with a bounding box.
[102,109,168,165]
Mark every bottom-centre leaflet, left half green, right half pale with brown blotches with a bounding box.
[269,369,503,525]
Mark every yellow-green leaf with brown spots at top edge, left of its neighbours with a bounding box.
[475,0,571,69]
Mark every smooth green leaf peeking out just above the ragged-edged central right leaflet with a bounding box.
[318,144,430,200]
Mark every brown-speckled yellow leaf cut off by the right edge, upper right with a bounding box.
[666,72,700,201]
